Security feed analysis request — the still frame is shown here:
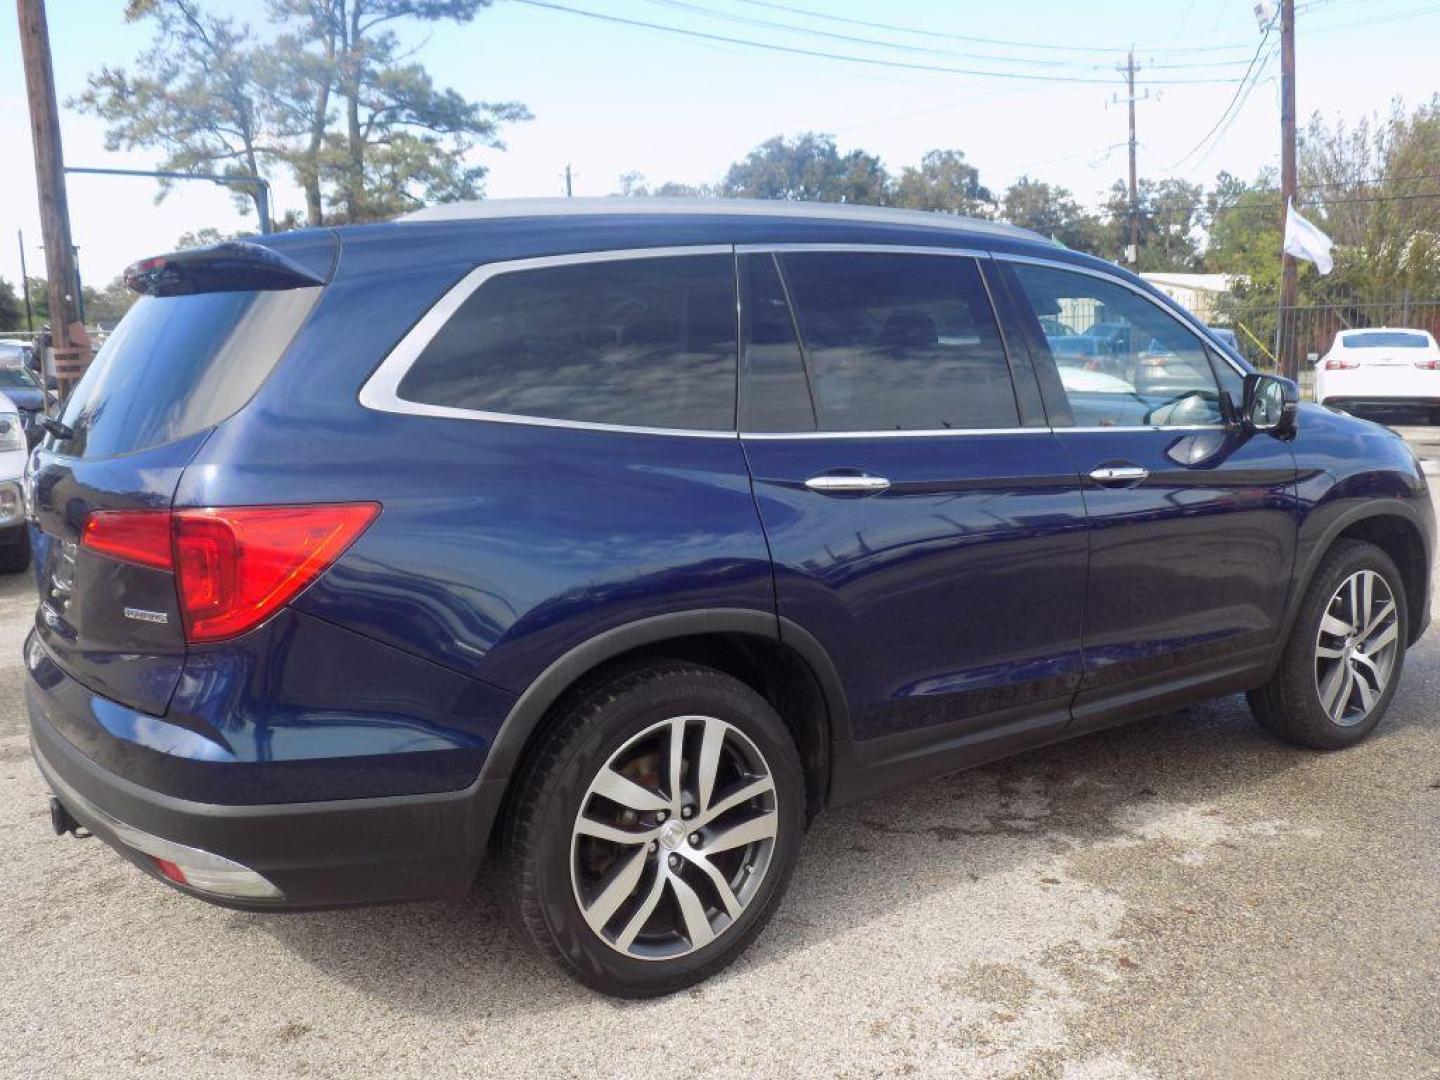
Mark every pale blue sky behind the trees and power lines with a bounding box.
[0,0,1440,284]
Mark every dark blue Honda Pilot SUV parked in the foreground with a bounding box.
[24,199,1434,996]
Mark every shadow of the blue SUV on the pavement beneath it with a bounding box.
[250,681,1434,1021]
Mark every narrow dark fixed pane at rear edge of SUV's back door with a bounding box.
[740,255,815,432]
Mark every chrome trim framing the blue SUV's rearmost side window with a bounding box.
[360,243,739,439]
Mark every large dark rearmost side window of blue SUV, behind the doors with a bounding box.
[399,255,736,431]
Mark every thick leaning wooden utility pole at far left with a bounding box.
[17,0,91,393]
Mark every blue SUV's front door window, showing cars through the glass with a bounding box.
[1014,265,1224,428]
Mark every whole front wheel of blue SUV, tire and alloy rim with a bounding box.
[1248,540,1408,750]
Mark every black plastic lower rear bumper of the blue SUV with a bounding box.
[26,680,503,910]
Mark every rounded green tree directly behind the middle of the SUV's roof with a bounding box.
[720,132,890,206]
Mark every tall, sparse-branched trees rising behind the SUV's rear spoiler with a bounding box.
[71,0,530,225]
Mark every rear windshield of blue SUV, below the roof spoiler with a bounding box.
[55,288,321,458]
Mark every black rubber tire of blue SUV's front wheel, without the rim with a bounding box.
[1247,540,1410,750]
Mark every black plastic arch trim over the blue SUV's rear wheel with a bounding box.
[478,608,850,829]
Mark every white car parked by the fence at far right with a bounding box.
[1315,327,1440,423]
